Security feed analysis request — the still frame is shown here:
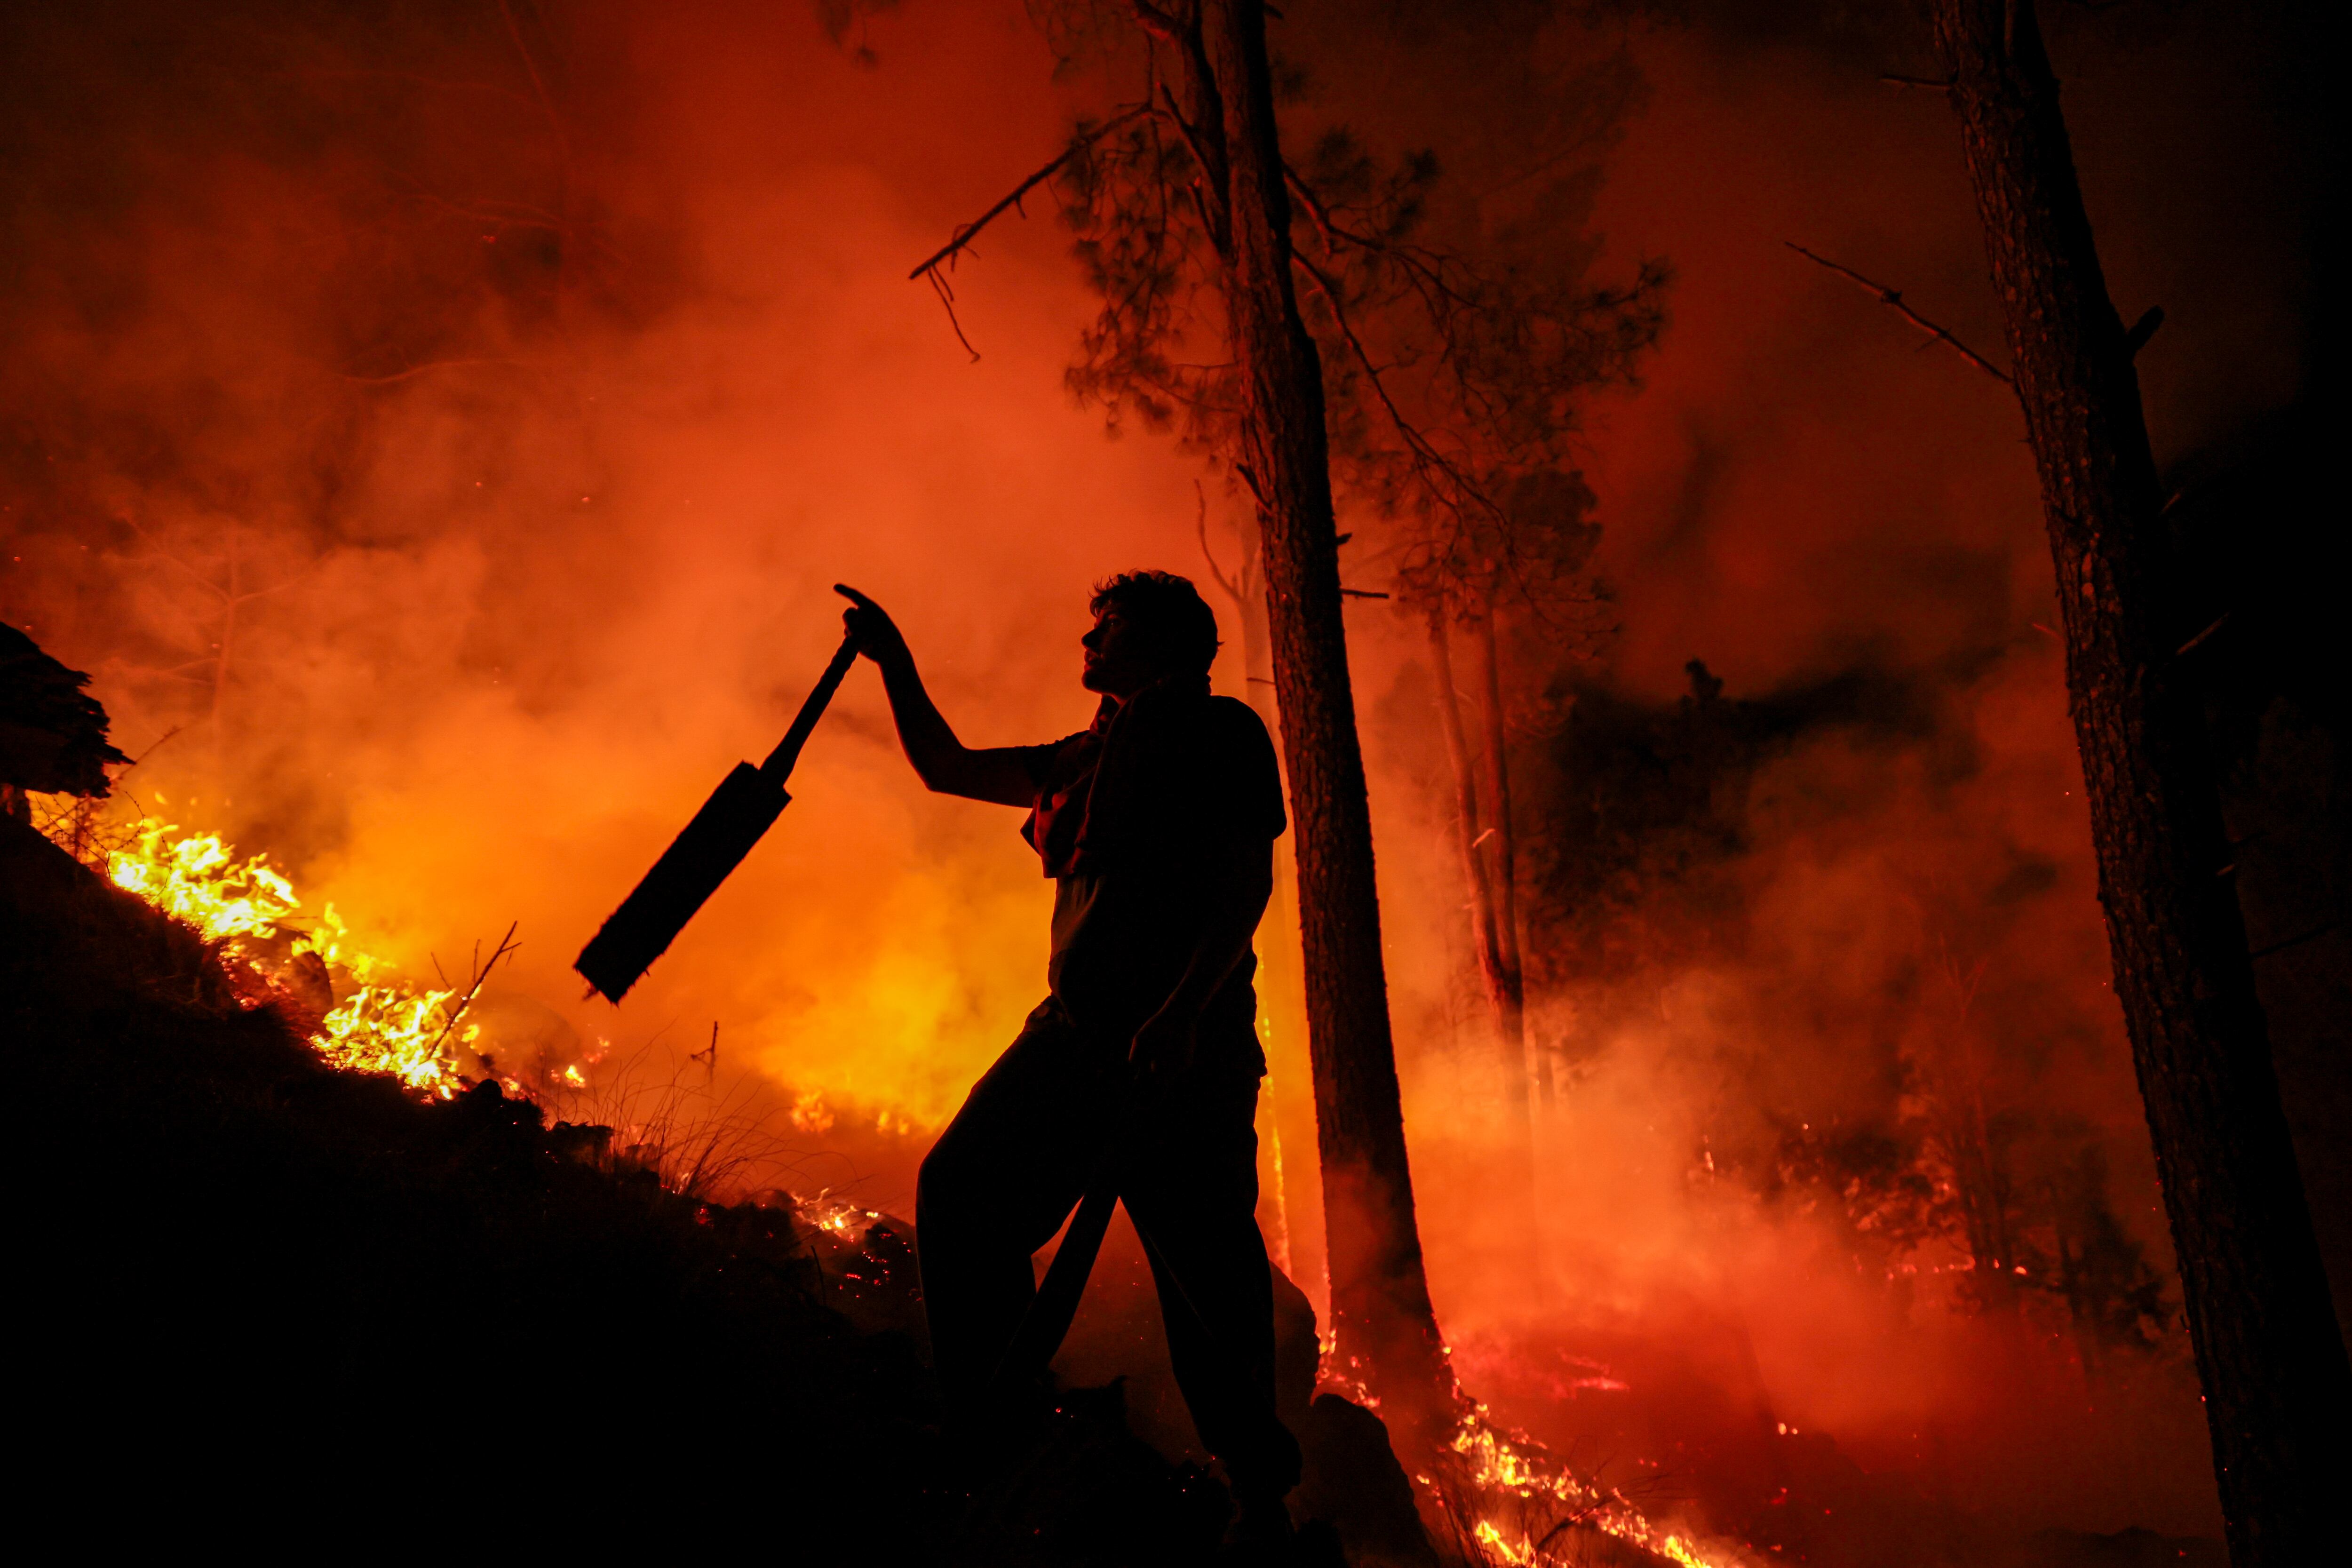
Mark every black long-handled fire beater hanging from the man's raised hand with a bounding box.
[572,637,858,1002]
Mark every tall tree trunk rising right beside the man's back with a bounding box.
[1188,0,1454,1413]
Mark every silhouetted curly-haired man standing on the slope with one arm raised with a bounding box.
[842,571,1298,1533]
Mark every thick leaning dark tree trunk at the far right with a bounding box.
[1936,0,2352,1568]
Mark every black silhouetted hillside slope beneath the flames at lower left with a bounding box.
[0,818,1409,1566]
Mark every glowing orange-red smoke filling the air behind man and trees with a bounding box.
[0,5,2312,1533]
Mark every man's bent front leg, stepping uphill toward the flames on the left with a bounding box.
[915,1002,1115,1415]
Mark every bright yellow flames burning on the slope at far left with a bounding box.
[42,811,470,1100]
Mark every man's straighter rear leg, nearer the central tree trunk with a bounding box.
[1122,1042,1298,1512]
